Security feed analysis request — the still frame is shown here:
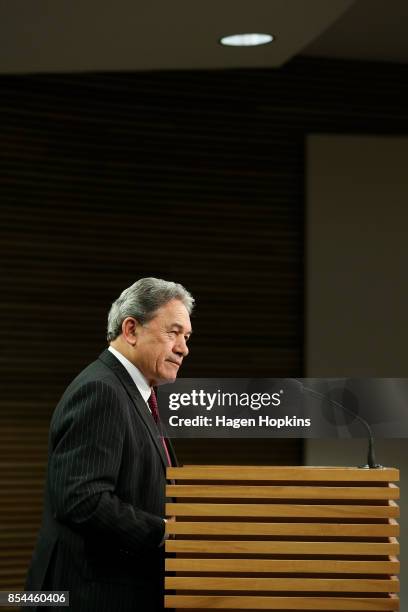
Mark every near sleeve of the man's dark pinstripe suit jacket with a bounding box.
[49,381,164,552]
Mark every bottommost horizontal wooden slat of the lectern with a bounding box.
[164,595,399,612]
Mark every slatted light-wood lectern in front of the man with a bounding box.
[165,465,399,612]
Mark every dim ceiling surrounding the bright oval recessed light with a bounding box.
[0,0,408,74]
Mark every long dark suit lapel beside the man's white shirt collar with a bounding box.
[99,349,170,469]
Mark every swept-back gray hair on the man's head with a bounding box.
[107,277,194,342]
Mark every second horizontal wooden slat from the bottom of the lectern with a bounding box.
[165,576,399,593]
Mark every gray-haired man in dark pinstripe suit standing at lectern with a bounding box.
[26,278,194,612]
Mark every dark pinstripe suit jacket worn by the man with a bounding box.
[25,350,174,612]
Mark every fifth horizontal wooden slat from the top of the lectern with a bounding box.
[165,538,399,555]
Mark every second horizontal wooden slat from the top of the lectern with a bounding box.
[166,480,399,499]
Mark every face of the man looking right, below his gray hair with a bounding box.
[133,299,191,386]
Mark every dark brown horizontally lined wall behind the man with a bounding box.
[0,58,408,588]
